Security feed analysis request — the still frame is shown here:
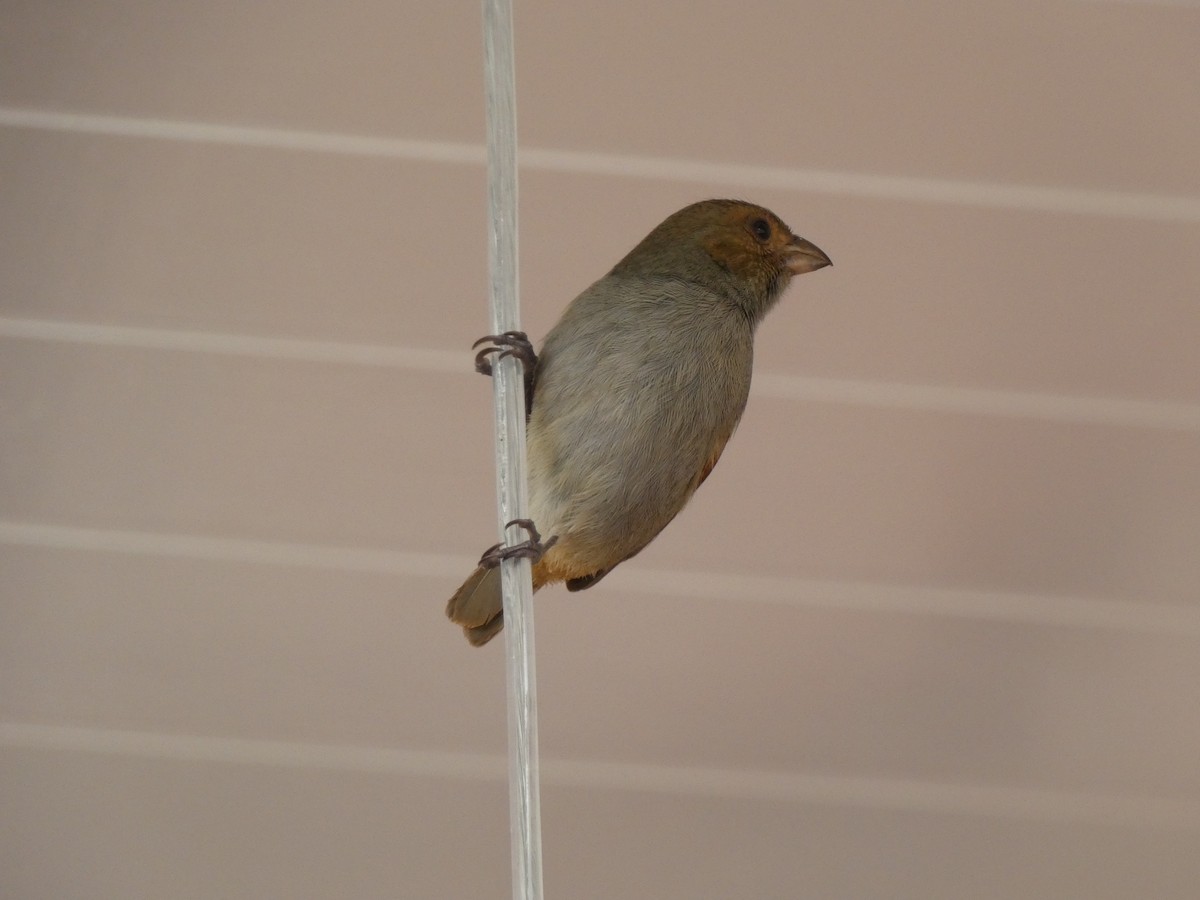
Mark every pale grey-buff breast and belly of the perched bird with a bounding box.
[529,282,752,564]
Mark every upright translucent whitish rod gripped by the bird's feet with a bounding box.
[484,0,541,900]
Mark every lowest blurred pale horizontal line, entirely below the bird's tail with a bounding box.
[0,721,1200,829]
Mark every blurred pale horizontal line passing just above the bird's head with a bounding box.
[0,107,1200,222]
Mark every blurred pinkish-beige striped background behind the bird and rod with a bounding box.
[0,0,1200,900]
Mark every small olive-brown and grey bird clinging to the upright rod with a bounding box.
[446,200,832,647]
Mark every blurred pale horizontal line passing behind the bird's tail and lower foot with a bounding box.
[0,520,1200,637]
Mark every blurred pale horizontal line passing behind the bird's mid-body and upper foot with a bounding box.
[0,317,1200,433]
